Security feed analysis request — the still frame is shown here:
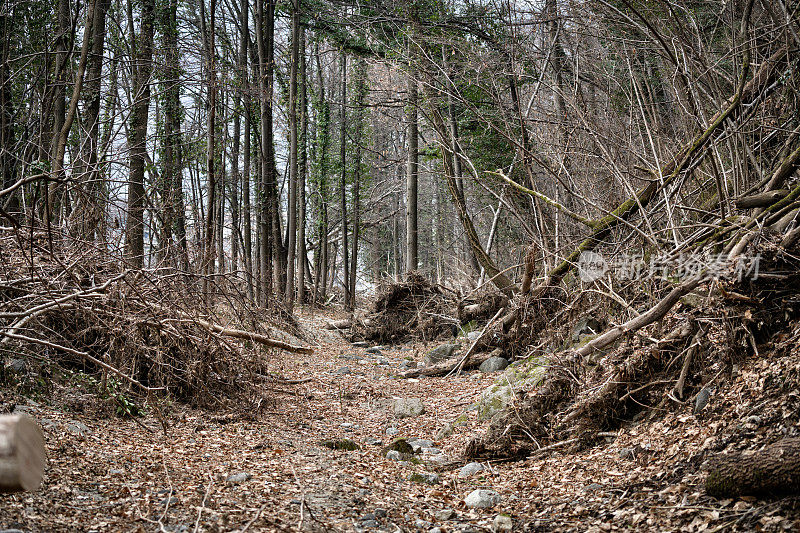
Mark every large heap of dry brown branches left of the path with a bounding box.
[0,233,306,407]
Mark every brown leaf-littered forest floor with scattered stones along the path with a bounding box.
[0,311,800,532]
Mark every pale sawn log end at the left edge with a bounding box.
[0,415,47,493]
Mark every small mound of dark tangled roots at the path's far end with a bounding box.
[352,272,460,343]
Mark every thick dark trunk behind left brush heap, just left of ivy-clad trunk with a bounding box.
[126,0,155,268]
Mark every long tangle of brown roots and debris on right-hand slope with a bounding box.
[466,237,800,458]
